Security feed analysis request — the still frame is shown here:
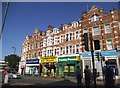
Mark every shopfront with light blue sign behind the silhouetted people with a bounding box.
[82,50,119,76]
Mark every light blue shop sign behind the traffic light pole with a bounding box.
[82,51,117,57]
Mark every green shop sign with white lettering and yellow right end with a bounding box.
[58,56,79,62]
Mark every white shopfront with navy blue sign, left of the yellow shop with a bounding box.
[25,59,40,76]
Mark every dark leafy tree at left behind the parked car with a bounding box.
[5,54,20,68]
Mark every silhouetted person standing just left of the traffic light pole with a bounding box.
[84,65,91,88]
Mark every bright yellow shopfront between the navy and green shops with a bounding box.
[41,56,57,77]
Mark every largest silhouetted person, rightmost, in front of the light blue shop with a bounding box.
[103,61,115,88]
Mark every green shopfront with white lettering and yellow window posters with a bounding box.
[58,55,80,77]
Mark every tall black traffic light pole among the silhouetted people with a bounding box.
[89,34,96,88]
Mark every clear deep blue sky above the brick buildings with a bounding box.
[0,2,118,60]
